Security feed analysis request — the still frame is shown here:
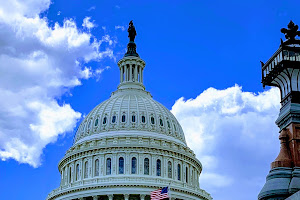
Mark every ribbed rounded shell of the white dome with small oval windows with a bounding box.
[74,89,186,145]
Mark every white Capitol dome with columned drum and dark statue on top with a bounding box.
[47,22,212,200]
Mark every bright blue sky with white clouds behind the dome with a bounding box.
[0,0,300,200]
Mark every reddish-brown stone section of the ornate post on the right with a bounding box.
[271,123,300,169]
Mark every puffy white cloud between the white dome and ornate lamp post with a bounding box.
[171,85,280,200]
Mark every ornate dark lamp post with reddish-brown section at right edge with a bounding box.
[258,21,300,200]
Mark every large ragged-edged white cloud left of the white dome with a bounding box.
[0,0,114,167]
